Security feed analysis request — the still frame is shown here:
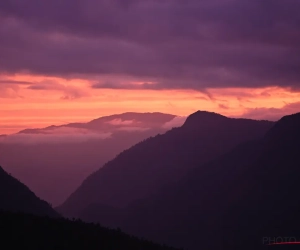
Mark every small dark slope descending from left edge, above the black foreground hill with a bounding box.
[0,167,58,217]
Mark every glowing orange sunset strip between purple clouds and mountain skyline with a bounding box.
[0,75,300,134]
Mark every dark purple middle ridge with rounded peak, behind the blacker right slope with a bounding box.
[58,111,273,218]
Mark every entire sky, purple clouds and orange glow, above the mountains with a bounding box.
[0,0,300,134]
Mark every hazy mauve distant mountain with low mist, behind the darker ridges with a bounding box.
[0,112,185,205]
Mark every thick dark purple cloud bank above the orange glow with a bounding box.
[0,0,300,89]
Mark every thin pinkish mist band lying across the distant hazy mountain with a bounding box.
[0,115,186,145]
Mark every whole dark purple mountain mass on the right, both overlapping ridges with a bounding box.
[58,112,300,250]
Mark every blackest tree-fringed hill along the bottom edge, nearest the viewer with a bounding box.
[0,212,180,250]
